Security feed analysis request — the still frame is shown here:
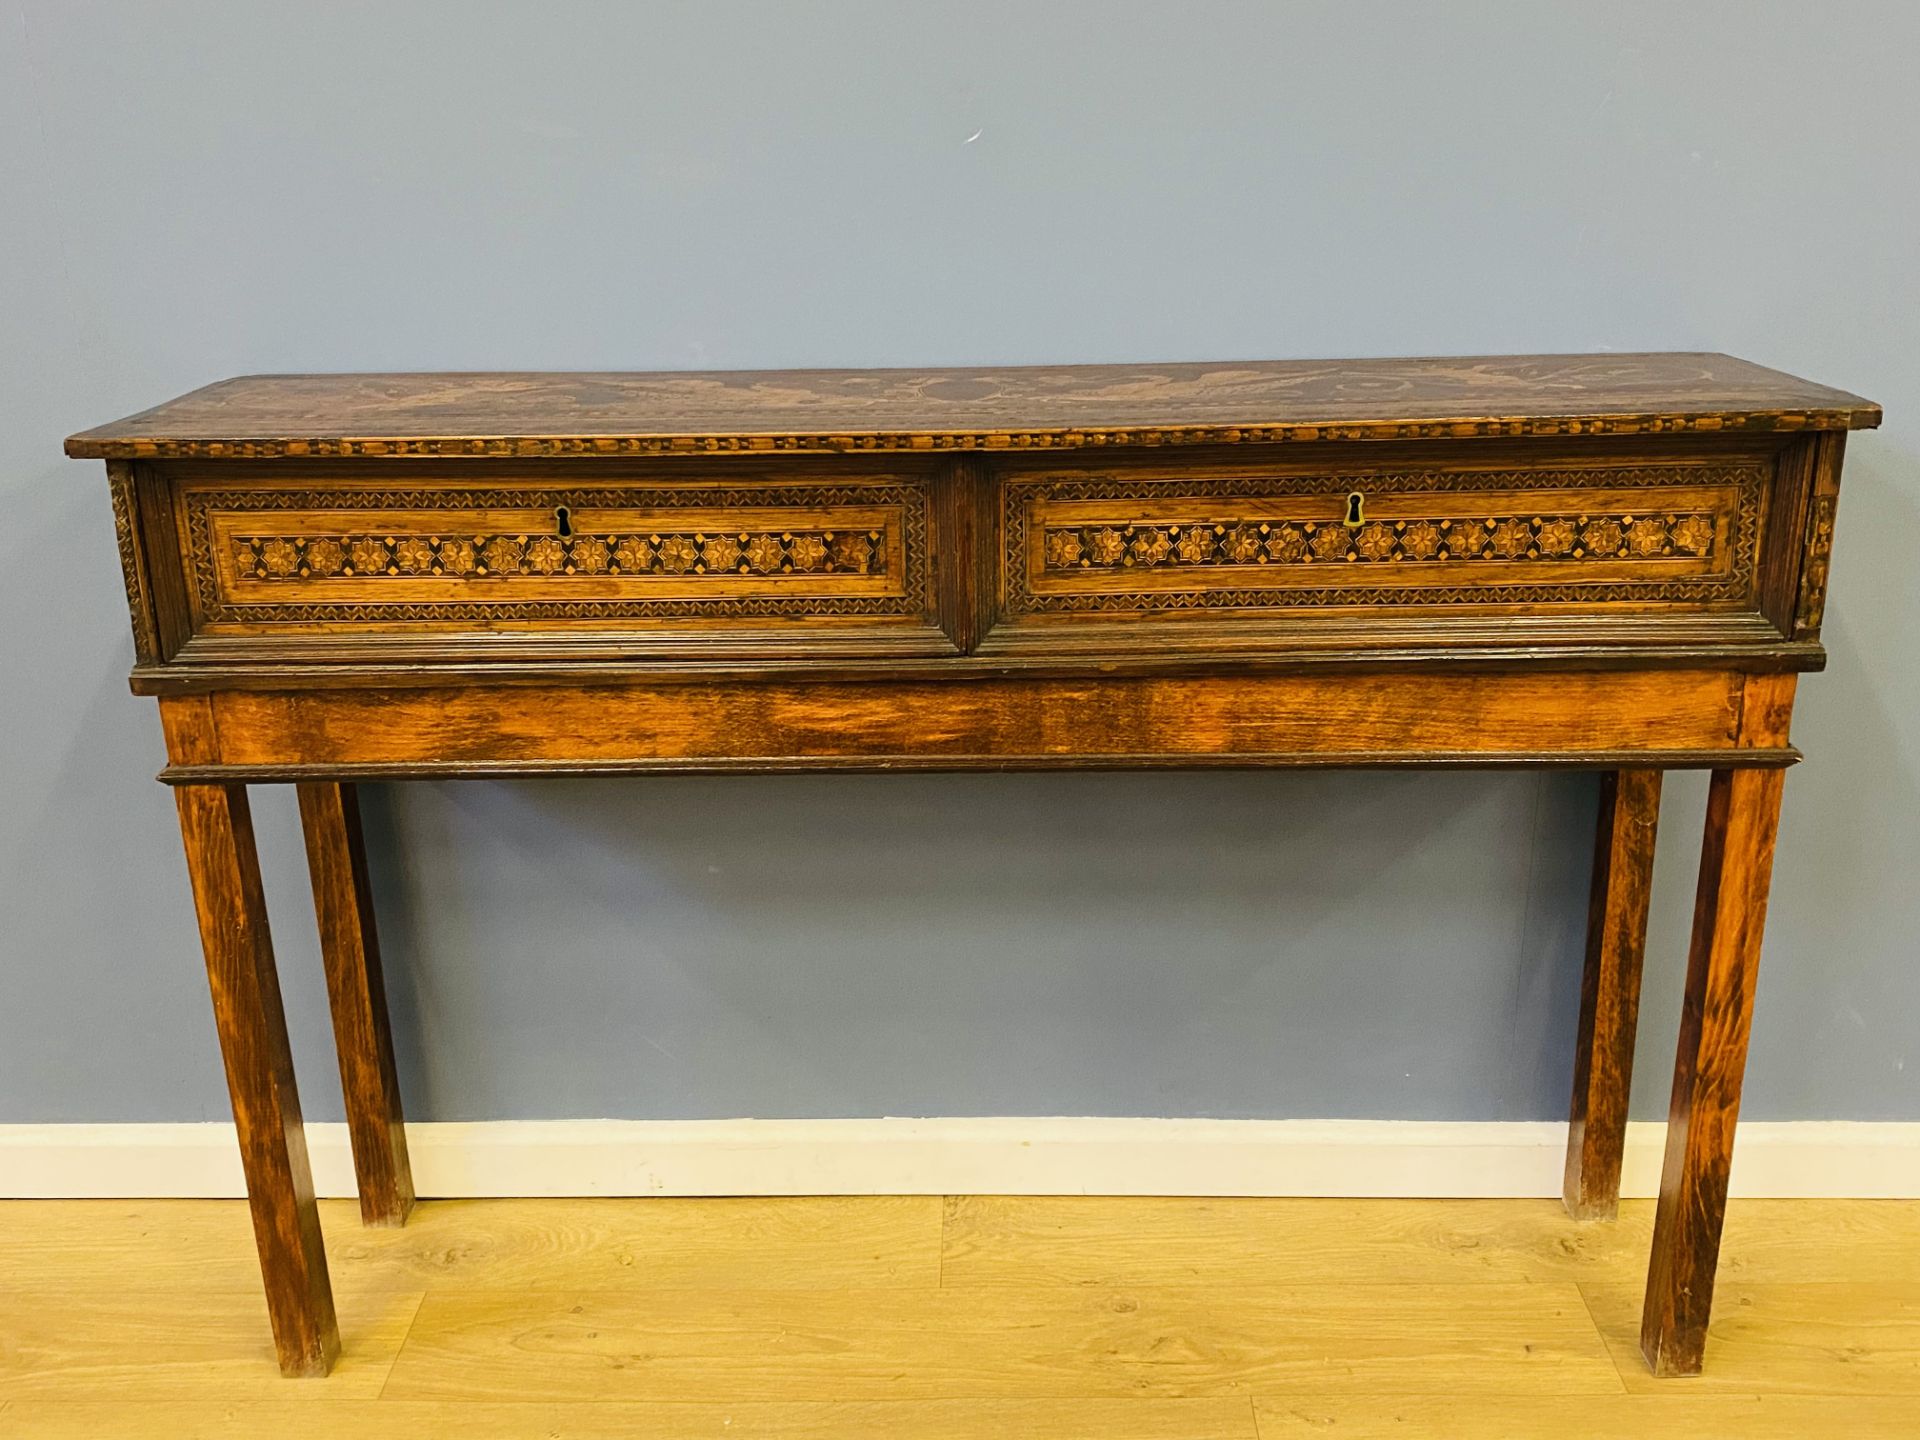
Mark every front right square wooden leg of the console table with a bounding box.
[1640,770,1786,1375]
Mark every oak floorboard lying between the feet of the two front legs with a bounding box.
[374,1284,1620,1402]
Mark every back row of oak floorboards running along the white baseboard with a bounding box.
[15,1196,1920,1297]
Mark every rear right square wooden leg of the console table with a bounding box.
[1561,770,1661,1219]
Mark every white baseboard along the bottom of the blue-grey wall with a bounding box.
[0,1119,1920,1198]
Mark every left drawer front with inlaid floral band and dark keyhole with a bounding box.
[182,482,929,634]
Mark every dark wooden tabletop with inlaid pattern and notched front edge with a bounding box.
[67,353,1880,459]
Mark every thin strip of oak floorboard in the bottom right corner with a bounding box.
[1254,1397,1916,1440]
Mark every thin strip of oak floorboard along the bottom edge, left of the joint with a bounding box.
[0,1400,1258,1440]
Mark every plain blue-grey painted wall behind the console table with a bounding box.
[0,0,1920,1121]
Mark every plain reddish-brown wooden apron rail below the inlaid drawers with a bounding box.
[172,670,1758,774]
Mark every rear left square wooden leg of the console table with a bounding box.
[300,781,413,1225]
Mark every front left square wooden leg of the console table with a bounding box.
[175,785,340,1375]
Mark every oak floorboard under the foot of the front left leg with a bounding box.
[0,1277,422,1405]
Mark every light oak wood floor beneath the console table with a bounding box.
[0,1196,1920,1440]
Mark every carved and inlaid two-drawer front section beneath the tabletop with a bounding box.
[97,420,1837,693]
